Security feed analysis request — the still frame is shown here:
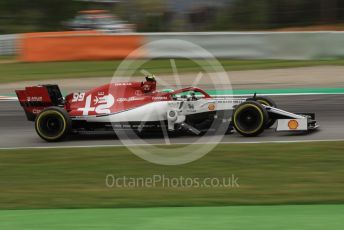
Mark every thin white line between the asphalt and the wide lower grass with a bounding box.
[0,139,344,150]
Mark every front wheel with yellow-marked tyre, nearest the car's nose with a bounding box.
[232,101,269,137]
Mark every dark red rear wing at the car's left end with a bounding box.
[15,85,64,121]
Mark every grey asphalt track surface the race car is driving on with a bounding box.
[0,94,344,149]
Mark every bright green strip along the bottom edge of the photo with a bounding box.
[0,205,344,230]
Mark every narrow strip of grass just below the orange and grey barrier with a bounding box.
[0,59,344,83]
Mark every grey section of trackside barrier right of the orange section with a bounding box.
[145,31,344,60]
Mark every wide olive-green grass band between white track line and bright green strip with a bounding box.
[0,142,344,209]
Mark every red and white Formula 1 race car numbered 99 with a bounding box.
[16,77,318,141]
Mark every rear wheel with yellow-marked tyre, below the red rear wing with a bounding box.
[35,106,72,142]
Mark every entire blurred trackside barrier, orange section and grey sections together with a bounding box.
[0,31,344,62]
